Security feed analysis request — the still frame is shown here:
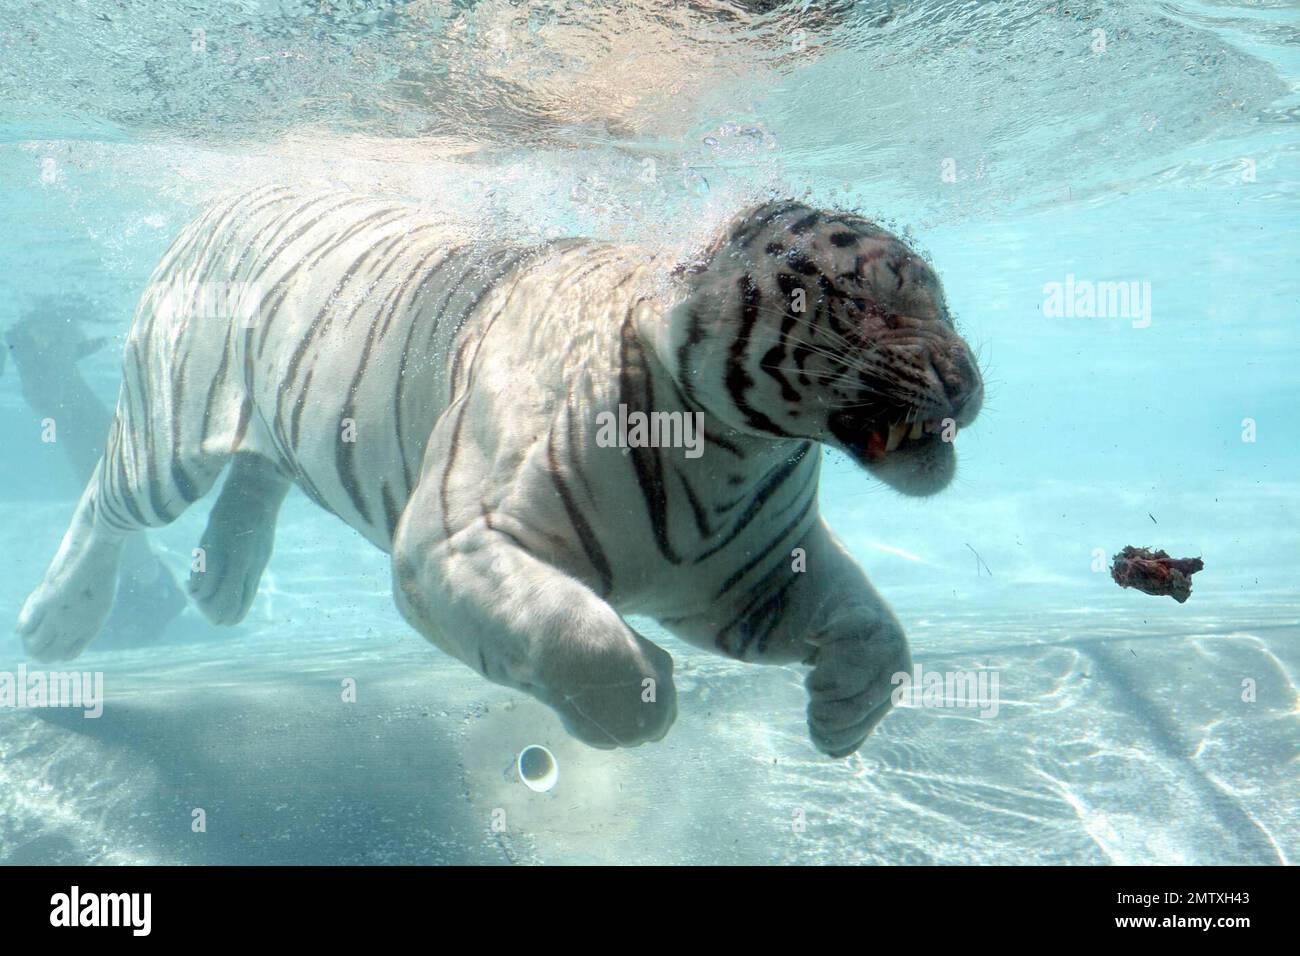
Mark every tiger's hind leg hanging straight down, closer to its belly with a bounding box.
[190,454,290,624]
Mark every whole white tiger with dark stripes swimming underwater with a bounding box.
[18,187,983,756]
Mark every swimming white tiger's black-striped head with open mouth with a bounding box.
[667,202,984,496]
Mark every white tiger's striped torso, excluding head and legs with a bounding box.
[129,189,820,614]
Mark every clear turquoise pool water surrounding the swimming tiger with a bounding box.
[0,0,1300,864]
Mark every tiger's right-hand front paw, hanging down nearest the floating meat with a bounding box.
[805,622,911,758]
